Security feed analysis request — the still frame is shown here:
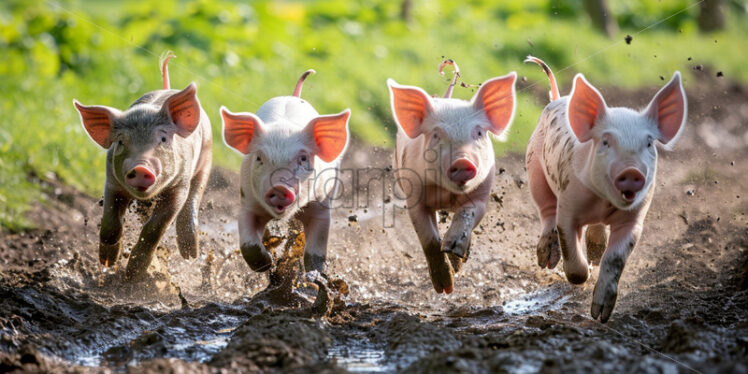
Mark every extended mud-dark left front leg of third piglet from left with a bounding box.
[408,204,454,293]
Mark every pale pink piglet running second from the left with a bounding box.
[221,70,351,272]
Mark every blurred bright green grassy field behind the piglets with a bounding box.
[0,0,748,230]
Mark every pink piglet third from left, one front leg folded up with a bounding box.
[387,60,517,293]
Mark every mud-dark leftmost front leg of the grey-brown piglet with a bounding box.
[99,188,130,267]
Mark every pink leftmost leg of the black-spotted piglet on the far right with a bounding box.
[527,150,561,269]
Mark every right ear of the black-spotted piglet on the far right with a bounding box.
[645,71,688,144]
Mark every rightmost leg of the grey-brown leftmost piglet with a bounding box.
[177,168,210,258]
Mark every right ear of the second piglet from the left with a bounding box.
[305,109,351,162]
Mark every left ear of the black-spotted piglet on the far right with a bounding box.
[567,74,606,142]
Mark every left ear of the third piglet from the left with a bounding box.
[387,79,431,139]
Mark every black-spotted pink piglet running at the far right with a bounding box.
[526,56,686,322]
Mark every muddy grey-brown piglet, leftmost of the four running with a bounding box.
[73,54,212,279]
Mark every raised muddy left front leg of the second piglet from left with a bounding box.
[239,208,273,272]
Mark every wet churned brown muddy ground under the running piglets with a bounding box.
[0,74,748,373]
